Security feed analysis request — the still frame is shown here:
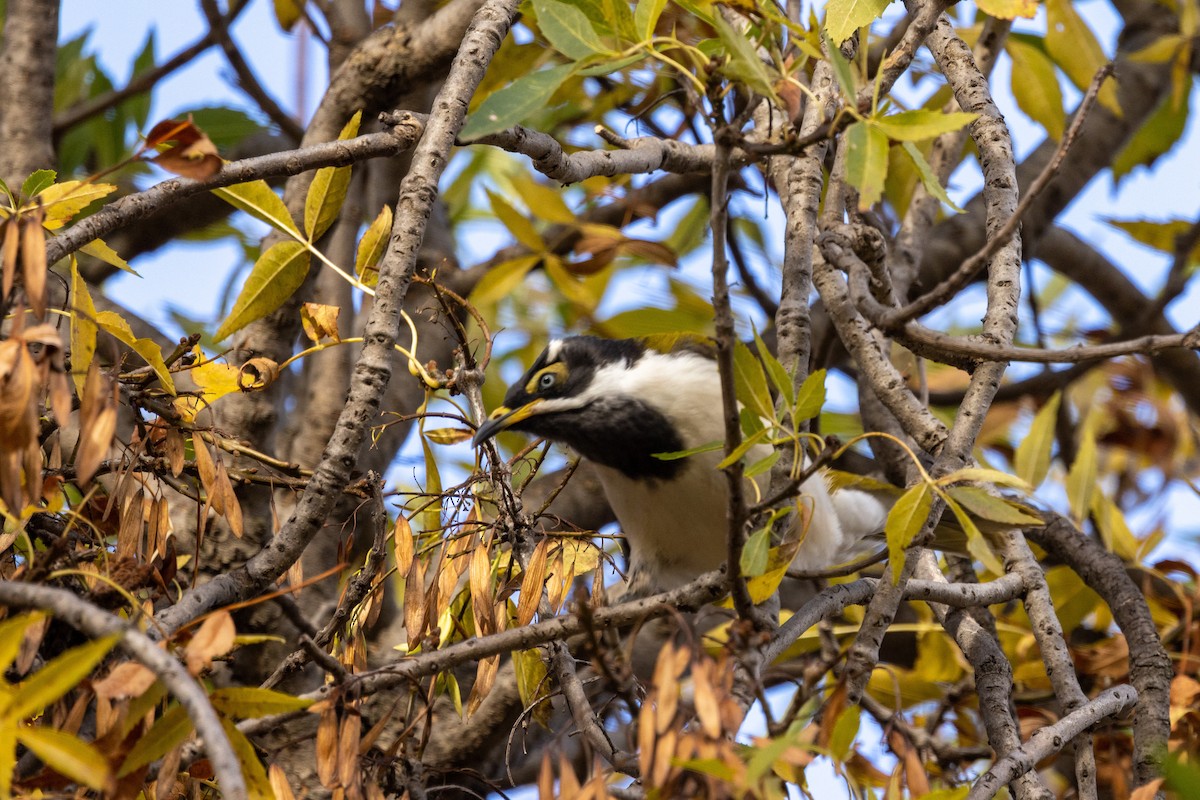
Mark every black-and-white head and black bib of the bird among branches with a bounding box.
[474,336,720,479]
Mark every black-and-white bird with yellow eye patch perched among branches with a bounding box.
[473,336,889,596]
